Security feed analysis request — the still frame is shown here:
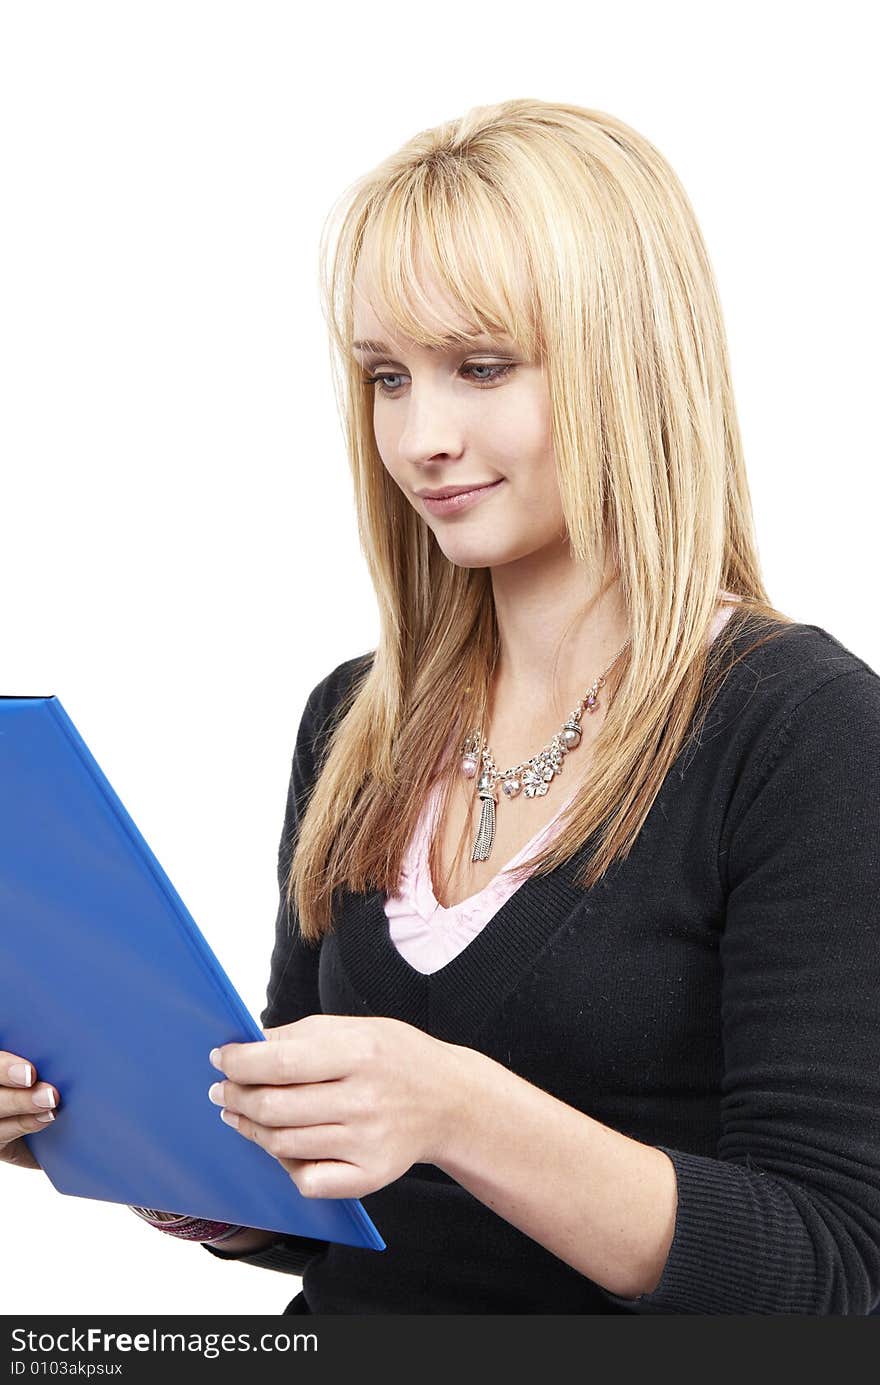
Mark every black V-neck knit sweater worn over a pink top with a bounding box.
[208,612,880,1314]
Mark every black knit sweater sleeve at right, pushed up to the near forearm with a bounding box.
[604,661,880,1316]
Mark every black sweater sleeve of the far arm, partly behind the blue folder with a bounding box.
[201,659,360,1274]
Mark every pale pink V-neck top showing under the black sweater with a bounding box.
[384,591,739,975]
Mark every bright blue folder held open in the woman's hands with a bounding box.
[0,695,385,1251]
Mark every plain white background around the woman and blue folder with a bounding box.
[0,0,880,1314]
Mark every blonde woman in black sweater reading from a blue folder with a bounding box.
[6,100,880,1314]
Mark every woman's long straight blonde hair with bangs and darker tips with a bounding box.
[287,98,793,942]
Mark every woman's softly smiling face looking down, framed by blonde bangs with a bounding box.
[353,267,565,568]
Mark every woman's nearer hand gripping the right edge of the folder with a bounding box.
[211,1015,460,1198]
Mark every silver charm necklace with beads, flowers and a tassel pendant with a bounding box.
[461,640,629,861]
